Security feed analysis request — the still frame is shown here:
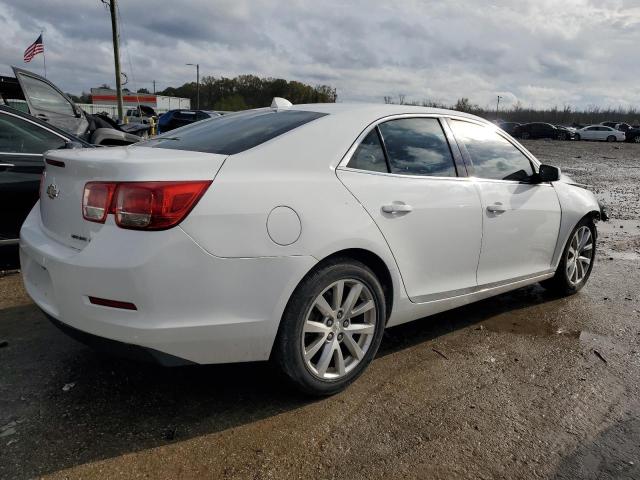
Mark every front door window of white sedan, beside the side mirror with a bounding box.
[450,120,533,181]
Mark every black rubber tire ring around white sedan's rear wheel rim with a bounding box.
[275,260,386,396]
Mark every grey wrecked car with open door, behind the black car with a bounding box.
[0,67,141,145]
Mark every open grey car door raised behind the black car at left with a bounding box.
[13,67,89,137]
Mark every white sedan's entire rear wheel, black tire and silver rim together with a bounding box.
[274,258,386,396]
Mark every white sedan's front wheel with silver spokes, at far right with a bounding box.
[540,217,597,296]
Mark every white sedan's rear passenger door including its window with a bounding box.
[337,117,482,302]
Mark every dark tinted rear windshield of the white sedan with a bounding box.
[148,109,327,155]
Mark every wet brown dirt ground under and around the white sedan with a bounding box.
[0,141,640,479]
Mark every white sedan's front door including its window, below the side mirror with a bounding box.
[449,119,560,287]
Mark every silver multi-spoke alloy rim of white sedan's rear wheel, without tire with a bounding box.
[302,279,377,380]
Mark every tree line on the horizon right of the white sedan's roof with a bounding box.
[384,95,640,125]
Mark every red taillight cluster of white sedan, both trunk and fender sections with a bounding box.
[82,180,211,230]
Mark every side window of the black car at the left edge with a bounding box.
[0,115,65,154]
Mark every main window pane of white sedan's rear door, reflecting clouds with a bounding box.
[379,118,456,177]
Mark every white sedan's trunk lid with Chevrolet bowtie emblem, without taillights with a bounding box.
[40,146,226,250]
